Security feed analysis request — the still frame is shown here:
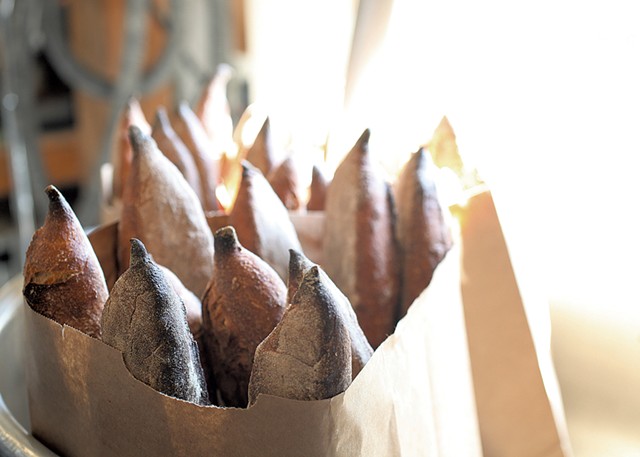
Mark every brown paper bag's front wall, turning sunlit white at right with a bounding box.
[26,214,481,457]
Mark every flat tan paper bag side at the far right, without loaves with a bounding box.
[459,187,571,457]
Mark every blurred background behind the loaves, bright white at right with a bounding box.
[0,0,640,457]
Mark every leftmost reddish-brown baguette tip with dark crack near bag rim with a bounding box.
[22,186,108,338]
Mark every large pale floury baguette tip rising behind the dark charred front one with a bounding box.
[118,127,218,297]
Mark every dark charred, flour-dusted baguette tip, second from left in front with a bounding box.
[102,239,209,405]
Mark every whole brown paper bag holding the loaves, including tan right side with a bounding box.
[26,187,569,457]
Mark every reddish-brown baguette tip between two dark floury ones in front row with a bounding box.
[202,227,287,407]
